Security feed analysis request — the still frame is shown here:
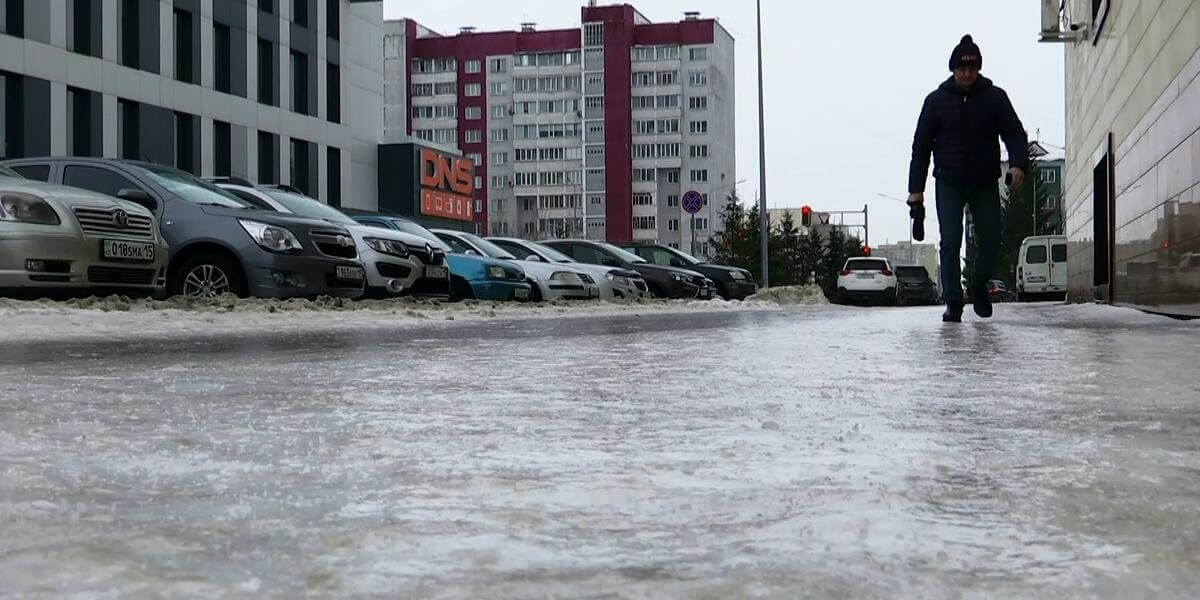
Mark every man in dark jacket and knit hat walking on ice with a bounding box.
[908,35,1030,323]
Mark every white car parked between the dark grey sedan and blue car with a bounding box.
[216,180,450,299]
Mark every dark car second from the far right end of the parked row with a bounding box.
[544,240,713,300]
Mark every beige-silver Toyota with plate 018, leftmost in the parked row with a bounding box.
[0,167,168,295]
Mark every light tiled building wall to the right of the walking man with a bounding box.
[1064,0,1200,314]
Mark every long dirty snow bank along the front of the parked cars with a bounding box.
[0,290,812,342]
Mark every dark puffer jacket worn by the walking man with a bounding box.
[908,77,1030,193]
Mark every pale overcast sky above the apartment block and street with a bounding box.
[384,0,1064,245]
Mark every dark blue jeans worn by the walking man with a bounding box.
[937,176,1000,304]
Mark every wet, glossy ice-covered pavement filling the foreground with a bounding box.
[0,305,1200,599]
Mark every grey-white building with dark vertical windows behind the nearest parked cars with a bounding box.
[0,0,384,208]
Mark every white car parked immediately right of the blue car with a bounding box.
[432,229,600,302]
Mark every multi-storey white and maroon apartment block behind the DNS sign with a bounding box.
[384,2,737,254]
